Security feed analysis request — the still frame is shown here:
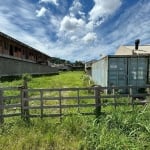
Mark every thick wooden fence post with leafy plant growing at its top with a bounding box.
[21,79,29,121]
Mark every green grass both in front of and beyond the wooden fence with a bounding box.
[0,72,150,150]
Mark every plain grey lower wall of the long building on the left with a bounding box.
[0,57,58,76]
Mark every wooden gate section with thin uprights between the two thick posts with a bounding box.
[22,88,99,119]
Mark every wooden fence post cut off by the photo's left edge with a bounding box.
[0,89,4,124]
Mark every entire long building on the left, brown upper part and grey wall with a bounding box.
[0,32,58,77]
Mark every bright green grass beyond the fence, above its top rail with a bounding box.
[0,71,84,88]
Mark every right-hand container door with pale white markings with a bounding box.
[128,57,148,90]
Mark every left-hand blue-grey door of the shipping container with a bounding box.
[108,58,127,89]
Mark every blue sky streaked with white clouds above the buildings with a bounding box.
[0,0,150,61]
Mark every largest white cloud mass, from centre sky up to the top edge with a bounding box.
[57,0,121,44]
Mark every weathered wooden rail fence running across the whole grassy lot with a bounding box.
[0,86,150,123]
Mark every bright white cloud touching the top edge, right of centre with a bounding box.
[89,0,121,26]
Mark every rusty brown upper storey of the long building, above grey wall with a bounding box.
[0,32,51,64]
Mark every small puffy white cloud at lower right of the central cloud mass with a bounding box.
[82,32,97,43]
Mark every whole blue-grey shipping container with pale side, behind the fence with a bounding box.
[92,55,150,93]
